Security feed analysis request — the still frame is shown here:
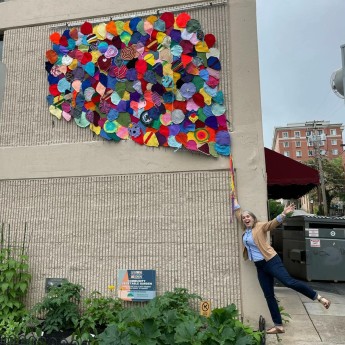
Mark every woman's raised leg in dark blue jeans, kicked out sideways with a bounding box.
[265,255,318,300]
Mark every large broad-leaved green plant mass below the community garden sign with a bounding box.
[98,289,261,345]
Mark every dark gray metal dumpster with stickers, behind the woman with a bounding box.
[282,215,345,282]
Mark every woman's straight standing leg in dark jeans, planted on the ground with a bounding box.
[255,260,283,326]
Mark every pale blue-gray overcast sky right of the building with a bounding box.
[257,0,345,148]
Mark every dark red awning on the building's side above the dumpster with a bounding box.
[265,147,320,199]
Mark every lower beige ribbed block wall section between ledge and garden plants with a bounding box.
[0,171,241,307]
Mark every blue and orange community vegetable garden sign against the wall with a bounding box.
[117,269,156,302]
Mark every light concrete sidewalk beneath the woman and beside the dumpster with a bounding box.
[266,287,345,345]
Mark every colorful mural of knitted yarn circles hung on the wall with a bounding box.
[46,12,230,157]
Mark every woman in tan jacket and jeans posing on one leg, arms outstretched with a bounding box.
[235,200,331,334]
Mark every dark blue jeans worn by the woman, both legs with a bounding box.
[255,255,317,326]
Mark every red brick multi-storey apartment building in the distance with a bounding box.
[272,121,344,162]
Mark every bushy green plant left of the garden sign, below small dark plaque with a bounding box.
[32,282,83,334]
